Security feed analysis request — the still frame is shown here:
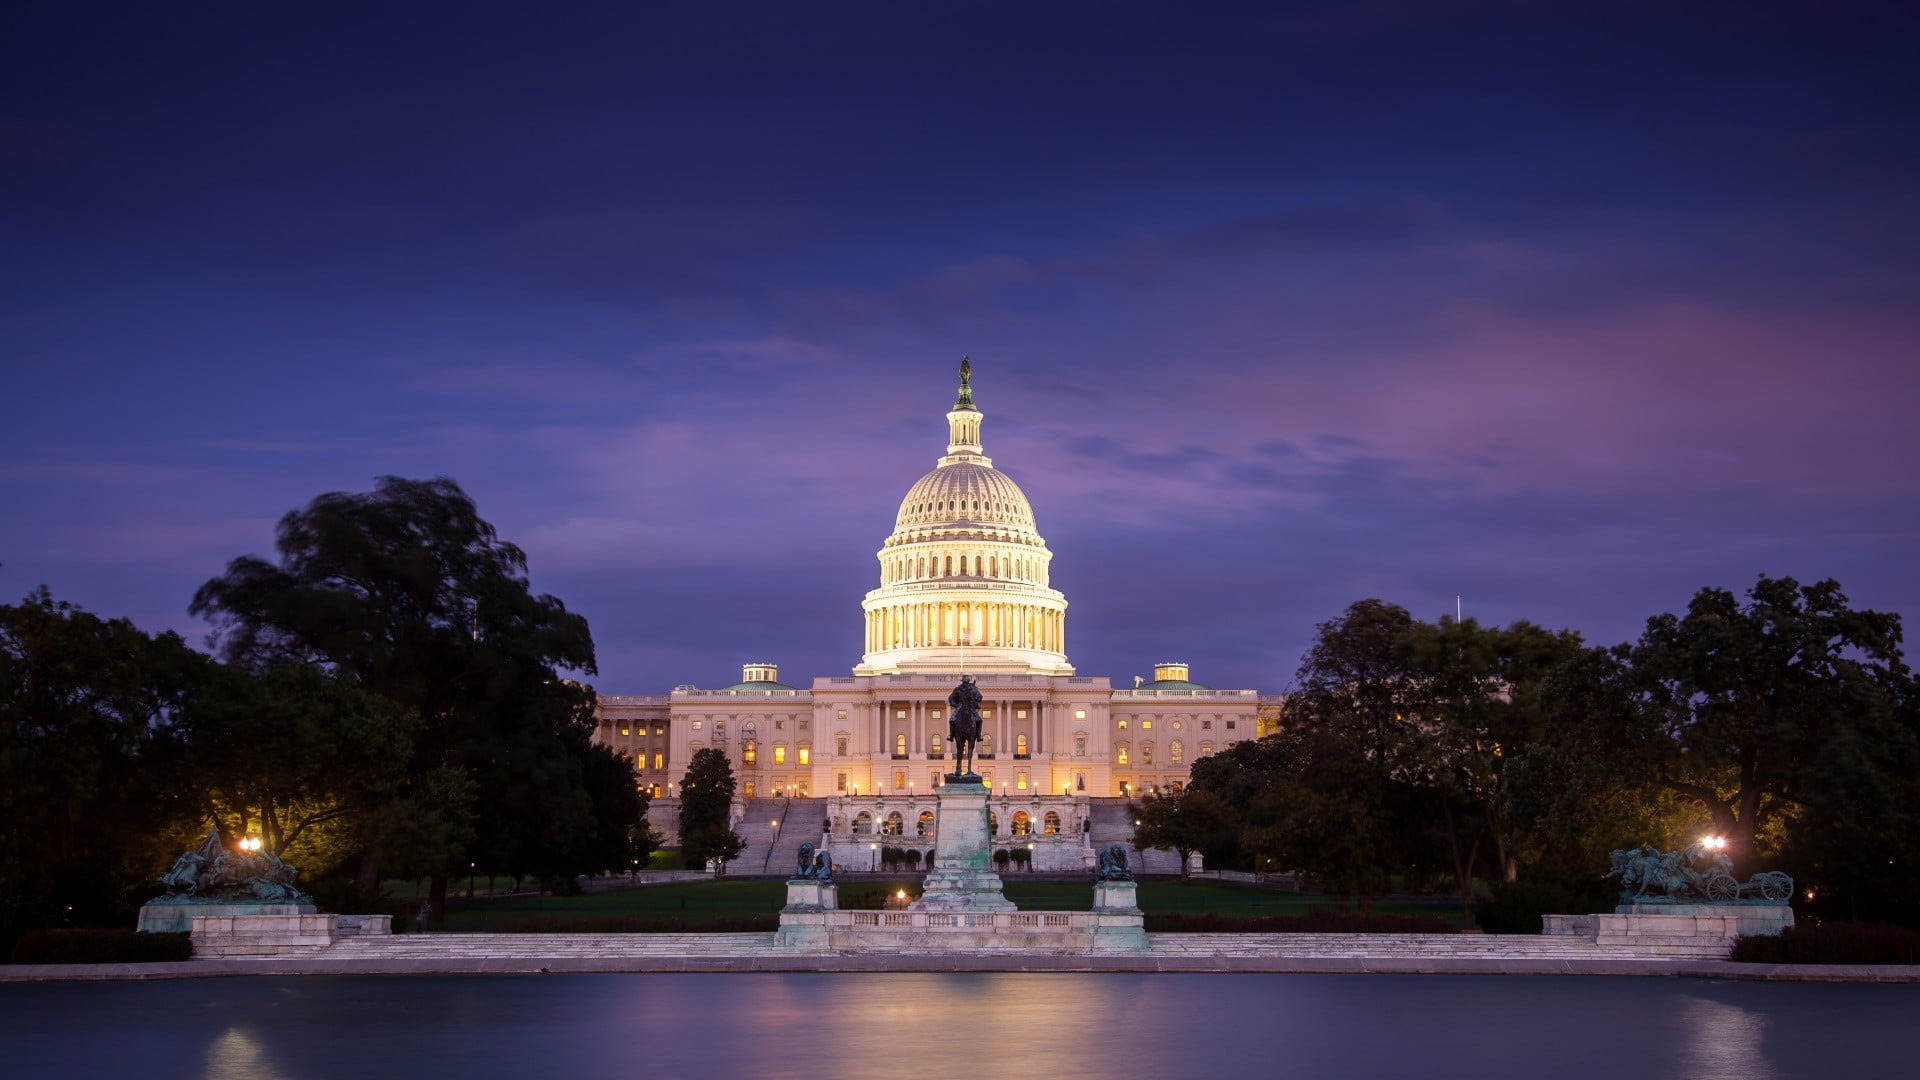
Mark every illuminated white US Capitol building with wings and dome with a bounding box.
[595,361,1279,865]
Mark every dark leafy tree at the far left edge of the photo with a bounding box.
[0,588,207,942]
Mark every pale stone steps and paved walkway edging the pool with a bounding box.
[0,934,1920,982]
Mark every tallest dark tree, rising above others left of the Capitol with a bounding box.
[190,477,632,919]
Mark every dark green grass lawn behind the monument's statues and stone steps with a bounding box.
[447,874,1471,930]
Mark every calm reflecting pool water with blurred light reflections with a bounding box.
[0,972,1920,1080]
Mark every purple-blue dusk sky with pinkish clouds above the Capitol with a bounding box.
[0,0,1920,694]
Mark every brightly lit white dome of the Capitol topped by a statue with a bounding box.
[854,359,1073,675]
